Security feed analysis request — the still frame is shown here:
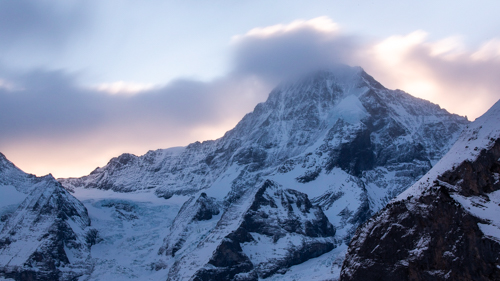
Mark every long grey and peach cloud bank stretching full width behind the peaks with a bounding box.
[0,17,500,177]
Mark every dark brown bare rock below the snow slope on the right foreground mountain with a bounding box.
[341,139,500,280]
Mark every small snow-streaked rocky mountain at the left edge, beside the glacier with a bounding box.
[0,154,96,280]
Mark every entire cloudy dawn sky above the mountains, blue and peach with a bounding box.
[0,0,500,177]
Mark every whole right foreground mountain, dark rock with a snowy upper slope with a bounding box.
[341,99,500,280]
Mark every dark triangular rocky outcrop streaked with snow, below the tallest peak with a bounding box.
[195,180,336,280]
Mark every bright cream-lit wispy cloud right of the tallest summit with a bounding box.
[358,31,500,120]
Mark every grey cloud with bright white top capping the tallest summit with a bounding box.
[232,17,358,83]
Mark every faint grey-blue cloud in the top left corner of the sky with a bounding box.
[0,0,91,64]
